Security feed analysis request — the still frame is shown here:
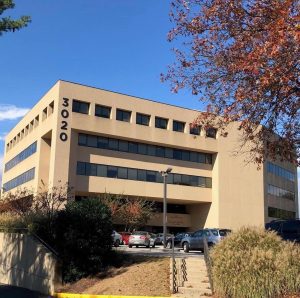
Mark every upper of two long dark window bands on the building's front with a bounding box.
[78,133,212,164]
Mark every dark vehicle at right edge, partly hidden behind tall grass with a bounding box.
[266,219,300,243]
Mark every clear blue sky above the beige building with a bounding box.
[0,0,298,207]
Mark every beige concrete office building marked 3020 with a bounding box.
[2,81,298,232]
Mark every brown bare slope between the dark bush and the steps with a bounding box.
[59,256,171,296]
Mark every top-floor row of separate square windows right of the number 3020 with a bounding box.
[72,100,217,138]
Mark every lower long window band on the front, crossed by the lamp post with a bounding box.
[77,161,212,188]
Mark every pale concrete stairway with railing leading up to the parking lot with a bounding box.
[172,257,212,298]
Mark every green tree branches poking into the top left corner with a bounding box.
[0,0,31,35]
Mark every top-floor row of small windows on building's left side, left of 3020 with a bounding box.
[6,101,54,151]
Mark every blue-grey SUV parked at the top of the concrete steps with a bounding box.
[180,229,231,252]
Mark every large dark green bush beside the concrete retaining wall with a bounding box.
[55,199,112,282]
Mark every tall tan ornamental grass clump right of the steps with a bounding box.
[211,228,300,298]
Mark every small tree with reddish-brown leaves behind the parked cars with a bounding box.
[100,193,155,231]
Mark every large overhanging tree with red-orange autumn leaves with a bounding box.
[162,0,300,165]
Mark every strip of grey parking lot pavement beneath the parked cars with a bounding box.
[113,245,204,257]
